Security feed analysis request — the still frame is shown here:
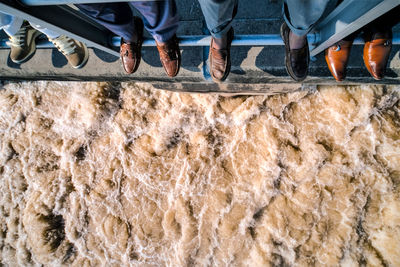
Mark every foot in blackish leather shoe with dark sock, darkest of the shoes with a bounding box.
[281,22,310,82]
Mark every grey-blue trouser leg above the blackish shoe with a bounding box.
[283,0,336,36]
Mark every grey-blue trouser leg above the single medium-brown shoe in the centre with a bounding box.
[199,0,238,38]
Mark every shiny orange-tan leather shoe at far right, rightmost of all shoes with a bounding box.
[364,30,392,80]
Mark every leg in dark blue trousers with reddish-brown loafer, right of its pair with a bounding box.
[130,0,181,77]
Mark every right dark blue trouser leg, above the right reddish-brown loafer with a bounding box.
[130,0,179,42]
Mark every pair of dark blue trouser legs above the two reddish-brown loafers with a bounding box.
[76,0,179,42]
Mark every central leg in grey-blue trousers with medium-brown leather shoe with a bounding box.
[199,0,238,82]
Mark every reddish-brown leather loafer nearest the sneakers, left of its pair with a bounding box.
[119,17,143,74]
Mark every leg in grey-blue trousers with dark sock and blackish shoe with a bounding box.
[281,0,336,81]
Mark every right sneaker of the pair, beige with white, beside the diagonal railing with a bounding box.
[49,35,89,69]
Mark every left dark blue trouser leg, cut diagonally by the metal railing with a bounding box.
[76,3,136,41]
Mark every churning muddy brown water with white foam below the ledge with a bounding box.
[0,82,400,266]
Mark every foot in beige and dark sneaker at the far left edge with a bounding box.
[9,21,41,63]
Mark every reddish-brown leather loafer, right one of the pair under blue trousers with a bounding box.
[156,35,181,77]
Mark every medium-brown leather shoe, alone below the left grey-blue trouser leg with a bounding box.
[208,28,235,83]
